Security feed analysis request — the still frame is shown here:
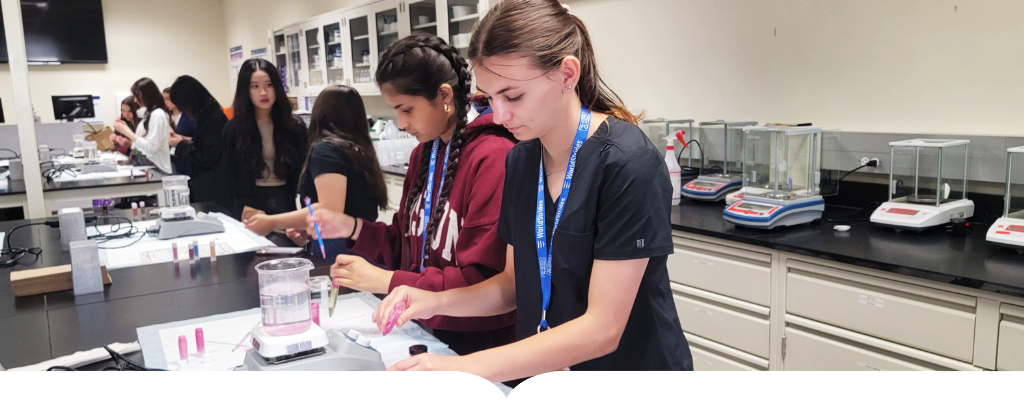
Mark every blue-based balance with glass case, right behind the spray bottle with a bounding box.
[683,120,758,202]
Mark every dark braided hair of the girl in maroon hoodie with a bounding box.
[375,34,472,267]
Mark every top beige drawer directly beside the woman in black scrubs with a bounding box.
[669,239,771,306]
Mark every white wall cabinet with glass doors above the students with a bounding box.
[269,0,497,97]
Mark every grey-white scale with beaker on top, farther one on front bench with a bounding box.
[148,175,224,240]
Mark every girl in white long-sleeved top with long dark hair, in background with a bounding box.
[114,77,174,174]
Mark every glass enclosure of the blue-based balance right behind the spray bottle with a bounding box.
[699,120,758,180]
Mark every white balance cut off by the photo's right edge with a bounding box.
[985,146,1024,253]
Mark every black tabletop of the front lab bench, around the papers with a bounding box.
[0,204,330,368]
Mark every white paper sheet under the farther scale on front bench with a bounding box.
[95,213,273,270]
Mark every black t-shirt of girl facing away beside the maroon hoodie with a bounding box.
[299,140,378,225]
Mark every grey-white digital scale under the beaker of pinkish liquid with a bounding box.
[236,324,386,371]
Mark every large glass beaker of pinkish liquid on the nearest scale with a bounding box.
[256,258,313,336]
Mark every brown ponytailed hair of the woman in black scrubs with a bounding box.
[469,0,640,124]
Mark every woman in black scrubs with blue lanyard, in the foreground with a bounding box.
[374,0,693,381]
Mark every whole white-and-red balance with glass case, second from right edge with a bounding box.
[871,138,974,232]
